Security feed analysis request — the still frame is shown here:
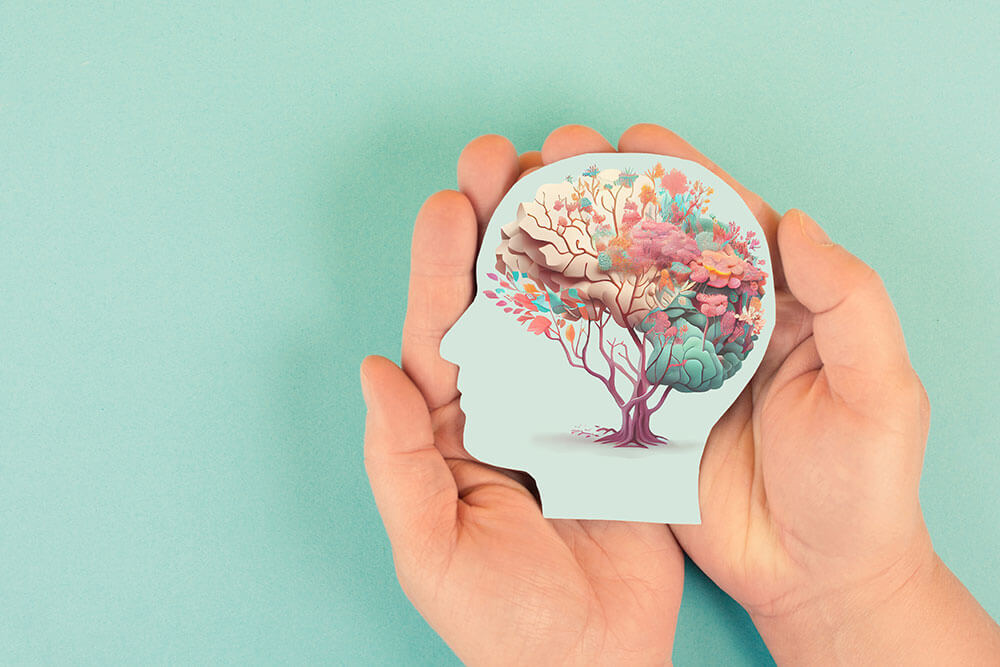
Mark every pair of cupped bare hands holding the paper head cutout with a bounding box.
[361,124,1000,665]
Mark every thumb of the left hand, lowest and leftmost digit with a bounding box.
[361,356,458,557]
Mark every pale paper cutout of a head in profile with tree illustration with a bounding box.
[442,154,774,523]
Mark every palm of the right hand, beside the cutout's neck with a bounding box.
[673,226,927,615]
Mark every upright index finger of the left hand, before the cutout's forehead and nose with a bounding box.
[402,190,476,410]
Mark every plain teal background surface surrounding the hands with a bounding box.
[0,1,1000,665]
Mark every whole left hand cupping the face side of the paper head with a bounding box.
[361,132,683,665]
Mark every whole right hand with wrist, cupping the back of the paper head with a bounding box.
[618,125,1000,664]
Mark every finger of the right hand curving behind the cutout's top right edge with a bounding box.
[618,123,784,287]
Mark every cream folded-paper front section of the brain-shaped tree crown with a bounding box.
[496,169,658,328]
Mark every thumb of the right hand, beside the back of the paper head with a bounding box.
[778,209,912,398]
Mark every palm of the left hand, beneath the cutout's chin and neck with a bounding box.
[414,404,682,664]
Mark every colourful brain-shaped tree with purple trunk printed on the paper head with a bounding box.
[484,164,767,447]
